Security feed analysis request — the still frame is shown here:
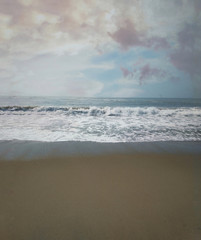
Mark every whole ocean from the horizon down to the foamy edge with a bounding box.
[0,97,201,143]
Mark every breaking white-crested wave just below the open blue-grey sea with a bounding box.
[0,106,201,117]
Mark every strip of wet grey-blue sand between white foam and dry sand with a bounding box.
[0,140,201,160]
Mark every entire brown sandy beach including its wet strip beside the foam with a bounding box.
[0,141,201,240]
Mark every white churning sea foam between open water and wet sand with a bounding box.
[0,106,201,142]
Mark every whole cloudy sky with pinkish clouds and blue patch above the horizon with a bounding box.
[0,0,201,98]
